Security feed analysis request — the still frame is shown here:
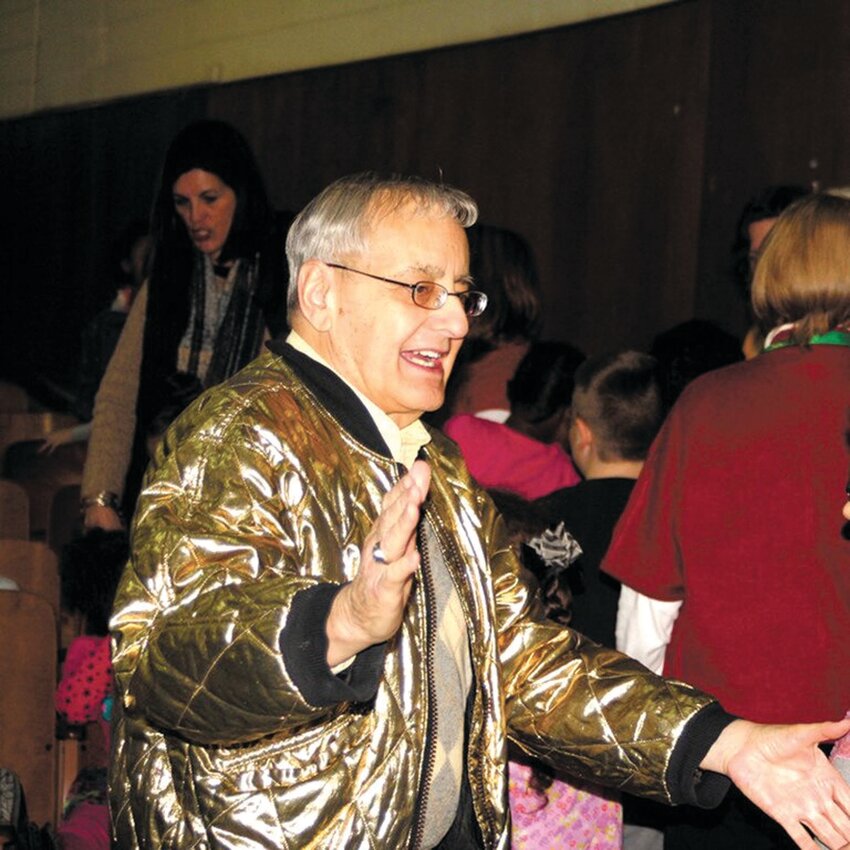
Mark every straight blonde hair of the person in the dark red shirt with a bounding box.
[752,193,850,345]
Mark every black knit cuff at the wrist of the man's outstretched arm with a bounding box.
[667,702,735,809]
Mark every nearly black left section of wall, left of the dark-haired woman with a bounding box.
[0,93,204,388]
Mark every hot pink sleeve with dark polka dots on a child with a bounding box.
[56,635,112,724]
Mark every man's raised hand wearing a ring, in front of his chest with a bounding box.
[326,460,431,667]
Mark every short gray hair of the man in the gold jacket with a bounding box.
[286,171,478,314]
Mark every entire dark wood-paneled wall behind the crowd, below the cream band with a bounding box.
[0,0,850,396]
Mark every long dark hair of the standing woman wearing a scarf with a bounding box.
[138,120,289,429]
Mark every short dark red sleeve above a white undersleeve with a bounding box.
[601,405,686,602]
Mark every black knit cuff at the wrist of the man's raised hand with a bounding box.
[280,584,386,707]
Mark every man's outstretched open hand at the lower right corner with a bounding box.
[702,720,850,850]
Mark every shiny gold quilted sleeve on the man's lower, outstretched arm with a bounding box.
[489,496,714,803]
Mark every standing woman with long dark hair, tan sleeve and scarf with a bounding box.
[82,120,286,529]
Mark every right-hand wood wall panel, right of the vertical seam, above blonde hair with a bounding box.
[696,0,850,330]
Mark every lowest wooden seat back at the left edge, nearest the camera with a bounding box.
[0,590,57,824]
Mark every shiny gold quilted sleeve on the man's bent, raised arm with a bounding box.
[112,394,354,744]
